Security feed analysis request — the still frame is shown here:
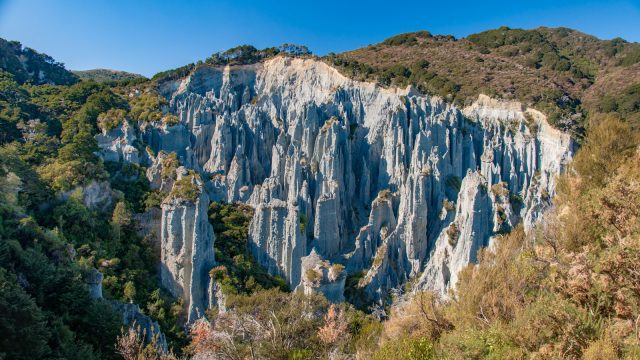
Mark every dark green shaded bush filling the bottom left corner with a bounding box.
[0,163,120,359]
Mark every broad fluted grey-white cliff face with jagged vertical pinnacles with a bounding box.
[141,57,572,304]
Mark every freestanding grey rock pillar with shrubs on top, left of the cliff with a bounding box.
[160,168,215,322]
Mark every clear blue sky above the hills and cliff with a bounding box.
[0,0,640,76]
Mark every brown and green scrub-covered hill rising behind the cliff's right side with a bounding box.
[326,27,640,138]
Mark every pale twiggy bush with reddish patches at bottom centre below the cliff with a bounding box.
[189,289,379,359]
